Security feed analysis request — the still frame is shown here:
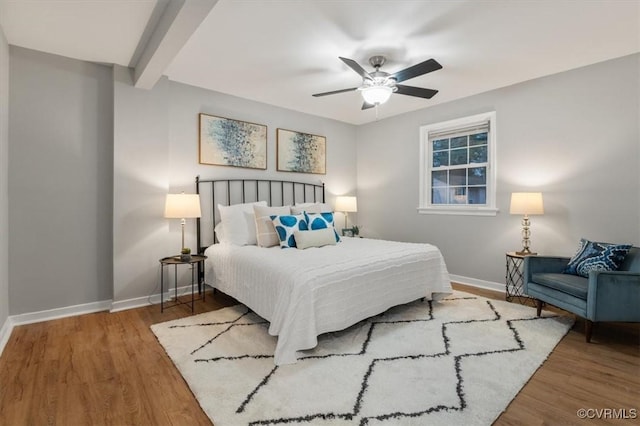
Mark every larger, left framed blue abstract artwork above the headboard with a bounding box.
[199,114,267,170]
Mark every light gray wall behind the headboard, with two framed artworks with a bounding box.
[113,67,356,309]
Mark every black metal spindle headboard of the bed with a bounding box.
[196,176,325,253]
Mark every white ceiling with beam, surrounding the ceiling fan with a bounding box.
[0,0,640,124]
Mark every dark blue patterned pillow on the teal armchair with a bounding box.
[562,238,631,278]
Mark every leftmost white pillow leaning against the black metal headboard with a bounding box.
[218,201,267,246]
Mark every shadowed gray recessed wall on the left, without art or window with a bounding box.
[9,46,113,315]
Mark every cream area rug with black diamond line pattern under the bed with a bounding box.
[151,291,573,426]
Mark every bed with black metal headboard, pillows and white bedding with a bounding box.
[196,178,452,365]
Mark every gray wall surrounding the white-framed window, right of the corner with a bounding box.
[357,55,640,283]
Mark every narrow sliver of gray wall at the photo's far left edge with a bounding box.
[0,27,9,326]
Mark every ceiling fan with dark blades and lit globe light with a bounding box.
[313,55,442,109]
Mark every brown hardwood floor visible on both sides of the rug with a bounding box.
[0,284,640,426]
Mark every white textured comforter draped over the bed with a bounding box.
[205,238,452,365]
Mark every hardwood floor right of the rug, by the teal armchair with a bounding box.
[454,284,640,426]
